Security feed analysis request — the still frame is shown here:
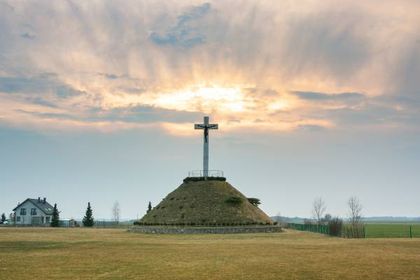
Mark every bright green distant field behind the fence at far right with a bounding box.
[365,223,420,238]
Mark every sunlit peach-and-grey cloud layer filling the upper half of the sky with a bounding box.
[0,0,420,133]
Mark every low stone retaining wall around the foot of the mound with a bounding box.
[128,225,282,234]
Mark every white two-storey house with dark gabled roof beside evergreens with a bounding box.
[13,197,54,225]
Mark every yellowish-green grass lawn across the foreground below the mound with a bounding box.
[0,228,420,280]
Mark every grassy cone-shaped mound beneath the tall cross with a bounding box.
[140,178,272,225]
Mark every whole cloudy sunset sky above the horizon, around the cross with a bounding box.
[0,0,420,219]
